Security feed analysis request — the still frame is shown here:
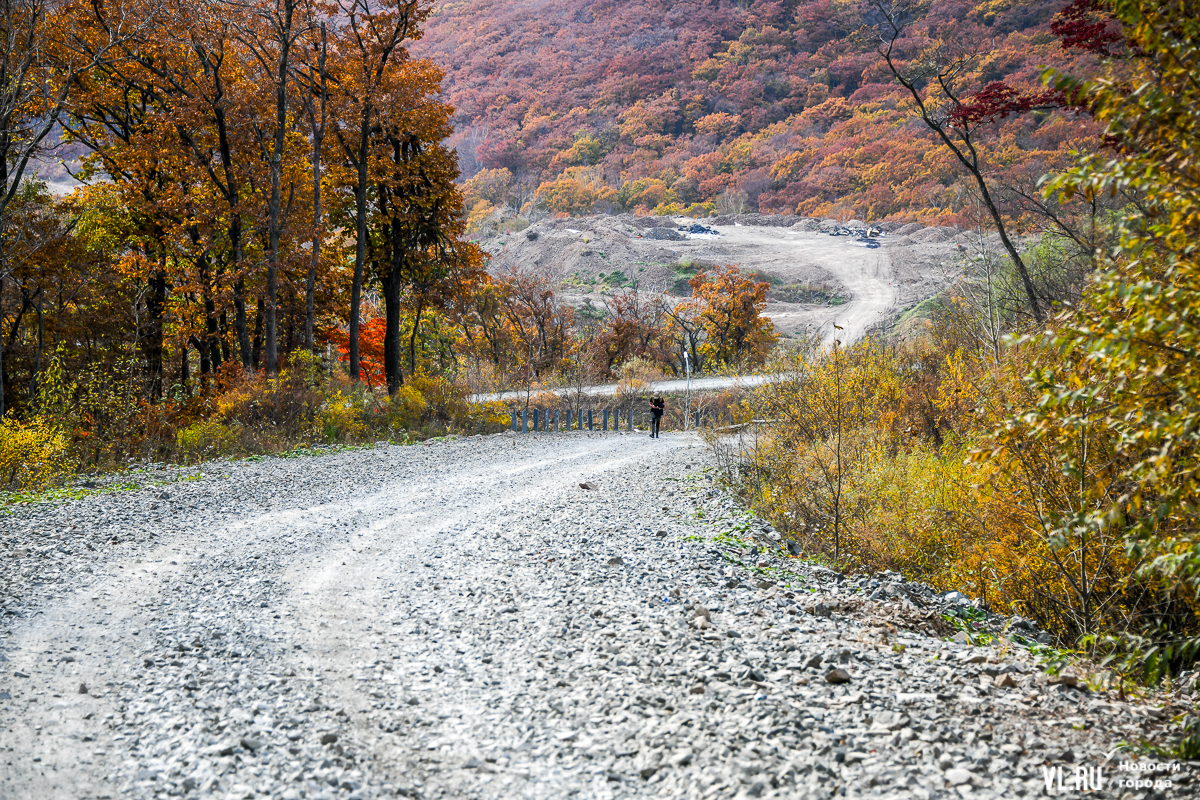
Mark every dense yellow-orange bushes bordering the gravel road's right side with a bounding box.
[744,343,1157,639]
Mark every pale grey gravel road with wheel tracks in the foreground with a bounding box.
[0,433,1196,800]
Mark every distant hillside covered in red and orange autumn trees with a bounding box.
[415,0,1097,221]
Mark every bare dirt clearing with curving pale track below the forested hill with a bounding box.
[481,216,962,343]
